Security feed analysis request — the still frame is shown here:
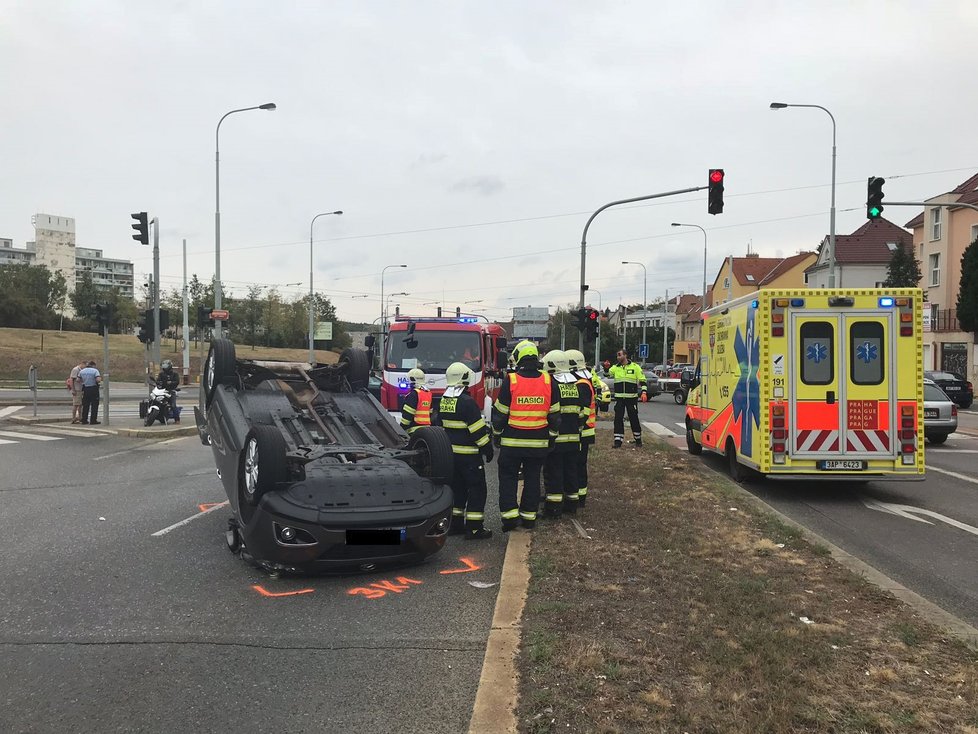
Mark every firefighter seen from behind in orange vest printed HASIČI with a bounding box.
[492,341,560,533]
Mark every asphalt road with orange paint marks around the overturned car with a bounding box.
[0,422,506,734]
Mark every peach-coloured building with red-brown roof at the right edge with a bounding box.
[906,174,978,381]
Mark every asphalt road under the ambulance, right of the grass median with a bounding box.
[626,395,978,626]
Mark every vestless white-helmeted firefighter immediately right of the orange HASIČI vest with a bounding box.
[543,349,591,518]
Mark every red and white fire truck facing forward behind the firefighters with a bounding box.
[380,313,507,415]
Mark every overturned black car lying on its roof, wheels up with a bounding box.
[194,339,453,573]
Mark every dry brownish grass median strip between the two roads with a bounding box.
[518,433,978,734]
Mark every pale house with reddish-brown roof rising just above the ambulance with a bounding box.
[805,218,912,288]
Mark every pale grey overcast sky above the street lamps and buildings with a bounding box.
[0,0,978,321]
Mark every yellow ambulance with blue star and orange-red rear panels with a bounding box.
[686,288,924,481]
